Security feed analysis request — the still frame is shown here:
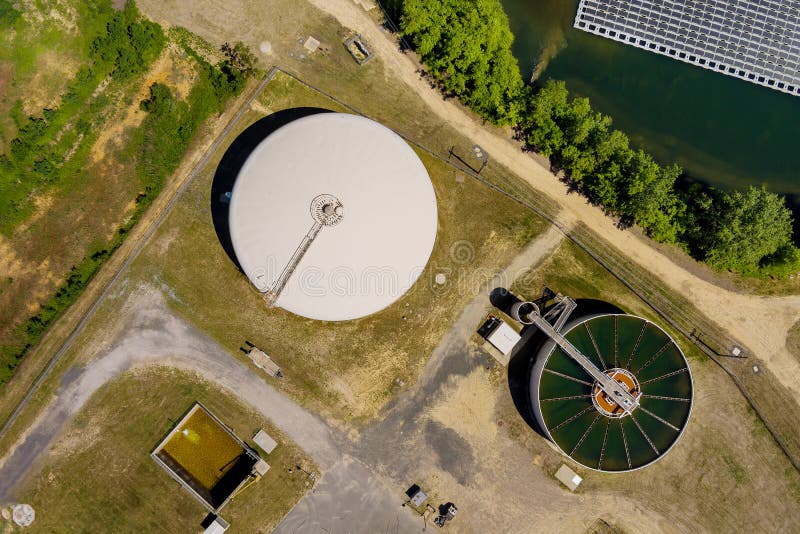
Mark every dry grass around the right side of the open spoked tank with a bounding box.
[503,240,800,531]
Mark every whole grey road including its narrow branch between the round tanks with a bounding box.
[0,229,561,533]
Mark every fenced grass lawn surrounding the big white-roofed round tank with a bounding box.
[131,74,544,421]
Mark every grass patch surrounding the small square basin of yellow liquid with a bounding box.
[17,367,317,532]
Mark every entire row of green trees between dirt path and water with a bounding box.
[400,0,800,274]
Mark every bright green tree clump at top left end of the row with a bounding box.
[400,0,523,124]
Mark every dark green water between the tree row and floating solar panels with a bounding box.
[501,0,800,197]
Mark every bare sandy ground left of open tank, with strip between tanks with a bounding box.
[352,224,691,533]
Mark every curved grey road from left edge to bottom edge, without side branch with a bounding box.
[0,288,432,533]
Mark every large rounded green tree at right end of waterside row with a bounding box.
[698,186,792,271]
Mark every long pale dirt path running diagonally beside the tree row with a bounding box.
[309,0,800,398]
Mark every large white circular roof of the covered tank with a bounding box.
[225,113,437,321]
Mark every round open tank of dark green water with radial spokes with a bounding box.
[530,314,693,472]
